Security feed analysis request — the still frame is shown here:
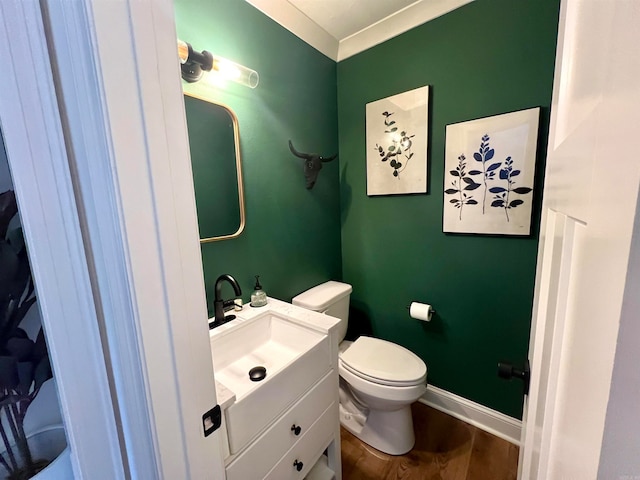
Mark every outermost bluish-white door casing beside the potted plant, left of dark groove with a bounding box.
[0,1,125,480]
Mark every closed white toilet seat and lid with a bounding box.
[339,336,427,387]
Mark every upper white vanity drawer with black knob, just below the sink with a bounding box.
[227,372,338,480]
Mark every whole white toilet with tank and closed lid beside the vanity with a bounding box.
[292,281,427,455]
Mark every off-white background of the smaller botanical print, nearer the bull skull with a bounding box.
[366,86,429,195]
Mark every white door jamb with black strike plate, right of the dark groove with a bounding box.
[43,0,224,479]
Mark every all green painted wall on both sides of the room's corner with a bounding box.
[175,0,559,417]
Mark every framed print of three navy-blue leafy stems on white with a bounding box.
[443,108,540,235]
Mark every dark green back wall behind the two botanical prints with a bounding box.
[338,0,559,418]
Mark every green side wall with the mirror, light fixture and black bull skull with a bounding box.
[175,0,341,312]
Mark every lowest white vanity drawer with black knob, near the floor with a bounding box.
[264,402,338,480]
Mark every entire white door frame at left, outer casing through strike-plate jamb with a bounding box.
[0,0,224,479]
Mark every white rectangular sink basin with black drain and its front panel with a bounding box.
[211,311,331,453]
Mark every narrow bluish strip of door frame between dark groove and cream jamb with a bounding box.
[42,0,160,479]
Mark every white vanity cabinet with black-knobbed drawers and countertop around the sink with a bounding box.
[212,299,342,480]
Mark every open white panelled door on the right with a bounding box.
[519,0,640,480]
